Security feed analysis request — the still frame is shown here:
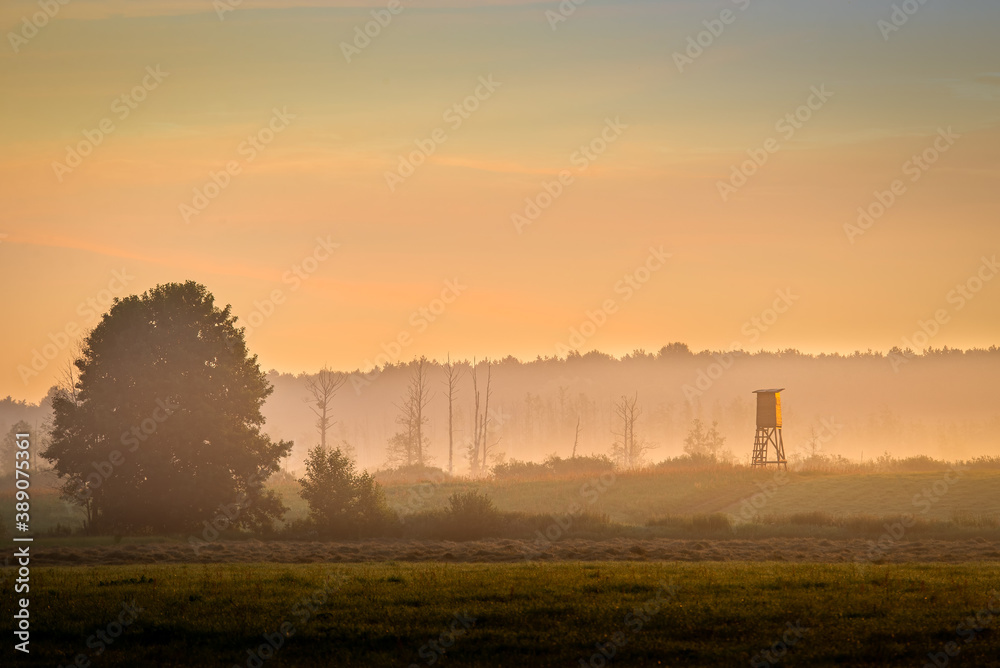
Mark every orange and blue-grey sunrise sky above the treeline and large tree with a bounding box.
[0,0,1000,401]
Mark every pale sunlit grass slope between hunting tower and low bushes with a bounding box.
[376,469,1000,525]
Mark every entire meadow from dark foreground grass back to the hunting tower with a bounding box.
[0,467,1000,668]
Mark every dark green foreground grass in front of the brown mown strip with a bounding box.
[0,563,1000,668]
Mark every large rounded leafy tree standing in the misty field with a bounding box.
[42,281,292,532]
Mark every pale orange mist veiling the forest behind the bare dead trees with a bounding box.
[0,344,1000,473]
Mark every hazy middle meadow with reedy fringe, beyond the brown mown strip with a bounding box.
[7,466,1000,545]
